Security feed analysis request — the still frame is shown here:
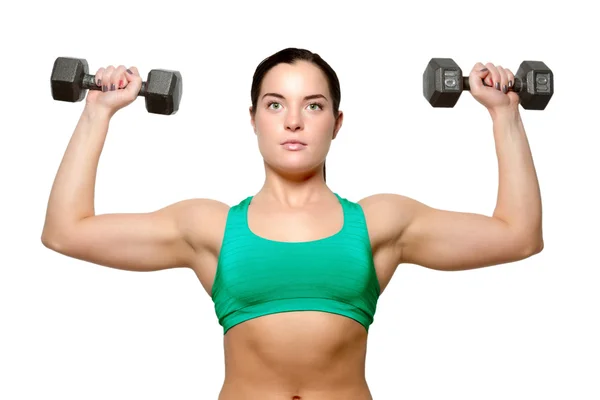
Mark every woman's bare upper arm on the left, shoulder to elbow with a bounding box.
[42,199,228,272]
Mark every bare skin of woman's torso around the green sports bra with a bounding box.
[188,192,404,400]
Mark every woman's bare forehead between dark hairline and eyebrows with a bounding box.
[261,61,329,96]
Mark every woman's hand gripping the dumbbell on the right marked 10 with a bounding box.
[469,63,519,114]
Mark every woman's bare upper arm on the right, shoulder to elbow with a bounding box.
[361,194,542,271]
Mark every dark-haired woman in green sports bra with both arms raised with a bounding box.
[42,49,543,400]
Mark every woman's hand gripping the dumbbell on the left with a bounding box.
[86,65,142,116]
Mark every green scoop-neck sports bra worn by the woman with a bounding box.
[212,193,380,334]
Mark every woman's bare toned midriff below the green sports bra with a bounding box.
[224,311,367,390]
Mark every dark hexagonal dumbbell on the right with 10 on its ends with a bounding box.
[423,58,554,110]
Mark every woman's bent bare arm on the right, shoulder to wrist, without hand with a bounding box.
[362,112,543,271]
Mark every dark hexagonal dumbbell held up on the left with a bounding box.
[50,57,182,115]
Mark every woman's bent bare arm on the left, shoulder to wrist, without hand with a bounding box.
[41,107,227,271]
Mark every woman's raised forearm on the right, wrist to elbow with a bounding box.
[491,111,542,245]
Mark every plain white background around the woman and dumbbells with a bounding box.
[0,0,600,400]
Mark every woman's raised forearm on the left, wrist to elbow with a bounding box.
[42,108,110,237]
